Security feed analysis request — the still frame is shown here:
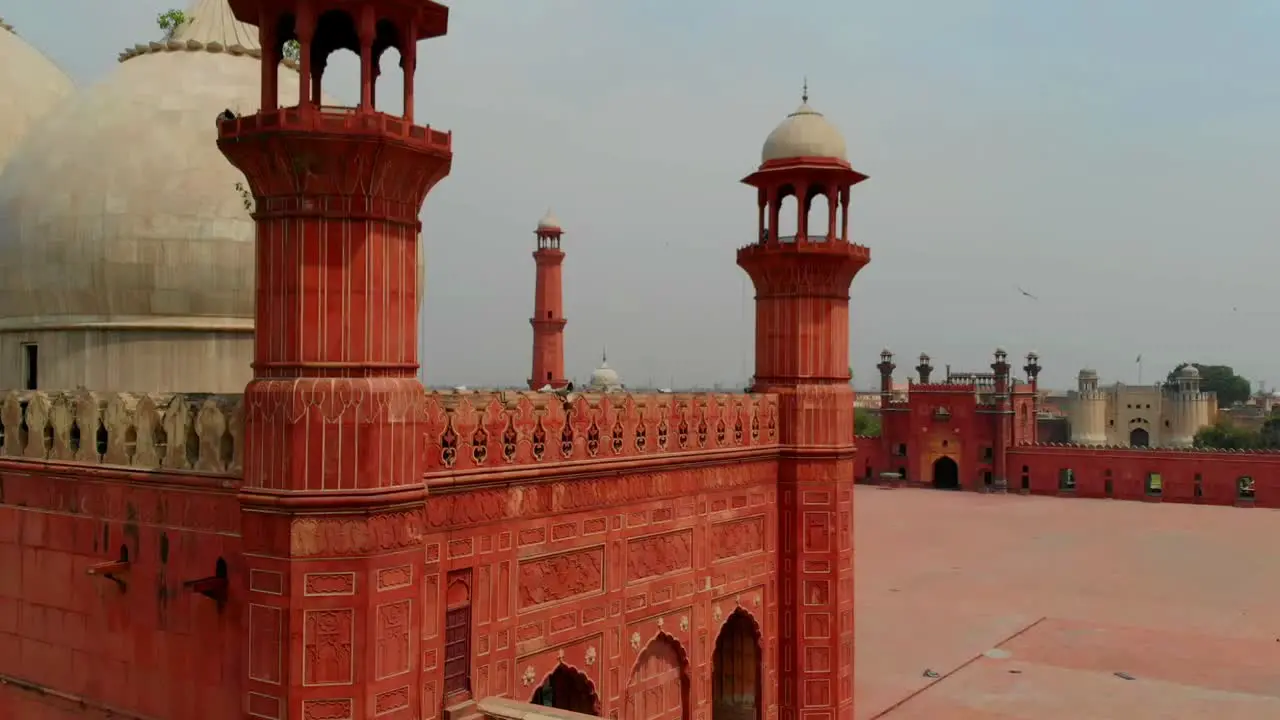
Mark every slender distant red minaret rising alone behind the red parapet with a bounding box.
[529,210,568,389]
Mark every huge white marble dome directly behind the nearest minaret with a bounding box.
[0,0,335,392]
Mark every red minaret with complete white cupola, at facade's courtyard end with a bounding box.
[737,90,870,717]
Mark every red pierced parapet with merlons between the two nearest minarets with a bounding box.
[426,392,778,473]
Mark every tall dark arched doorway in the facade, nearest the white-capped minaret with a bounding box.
[712,607,764,720]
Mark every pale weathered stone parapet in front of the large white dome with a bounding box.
[0,389,244,475]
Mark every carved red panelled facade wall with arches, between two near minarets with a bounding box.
[422,459,777,720]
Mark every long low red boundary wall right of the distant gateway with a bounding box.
[1009,446,1280,507]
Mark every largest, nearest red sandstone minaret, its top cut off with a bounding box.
[220,0,453,720]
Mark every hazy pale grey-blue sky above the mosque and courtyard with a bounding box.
[10,0,1280,386]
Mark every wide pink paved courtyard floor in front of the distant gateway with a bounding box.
[855,487,1280,720]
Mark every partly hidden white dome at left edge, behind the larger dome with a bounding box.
[0,19,76,169]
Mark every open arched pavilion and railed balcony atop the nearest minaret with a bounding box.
[218,0,452,156]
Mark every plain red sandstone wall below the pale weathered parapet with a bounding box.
[0,459,244,720]
